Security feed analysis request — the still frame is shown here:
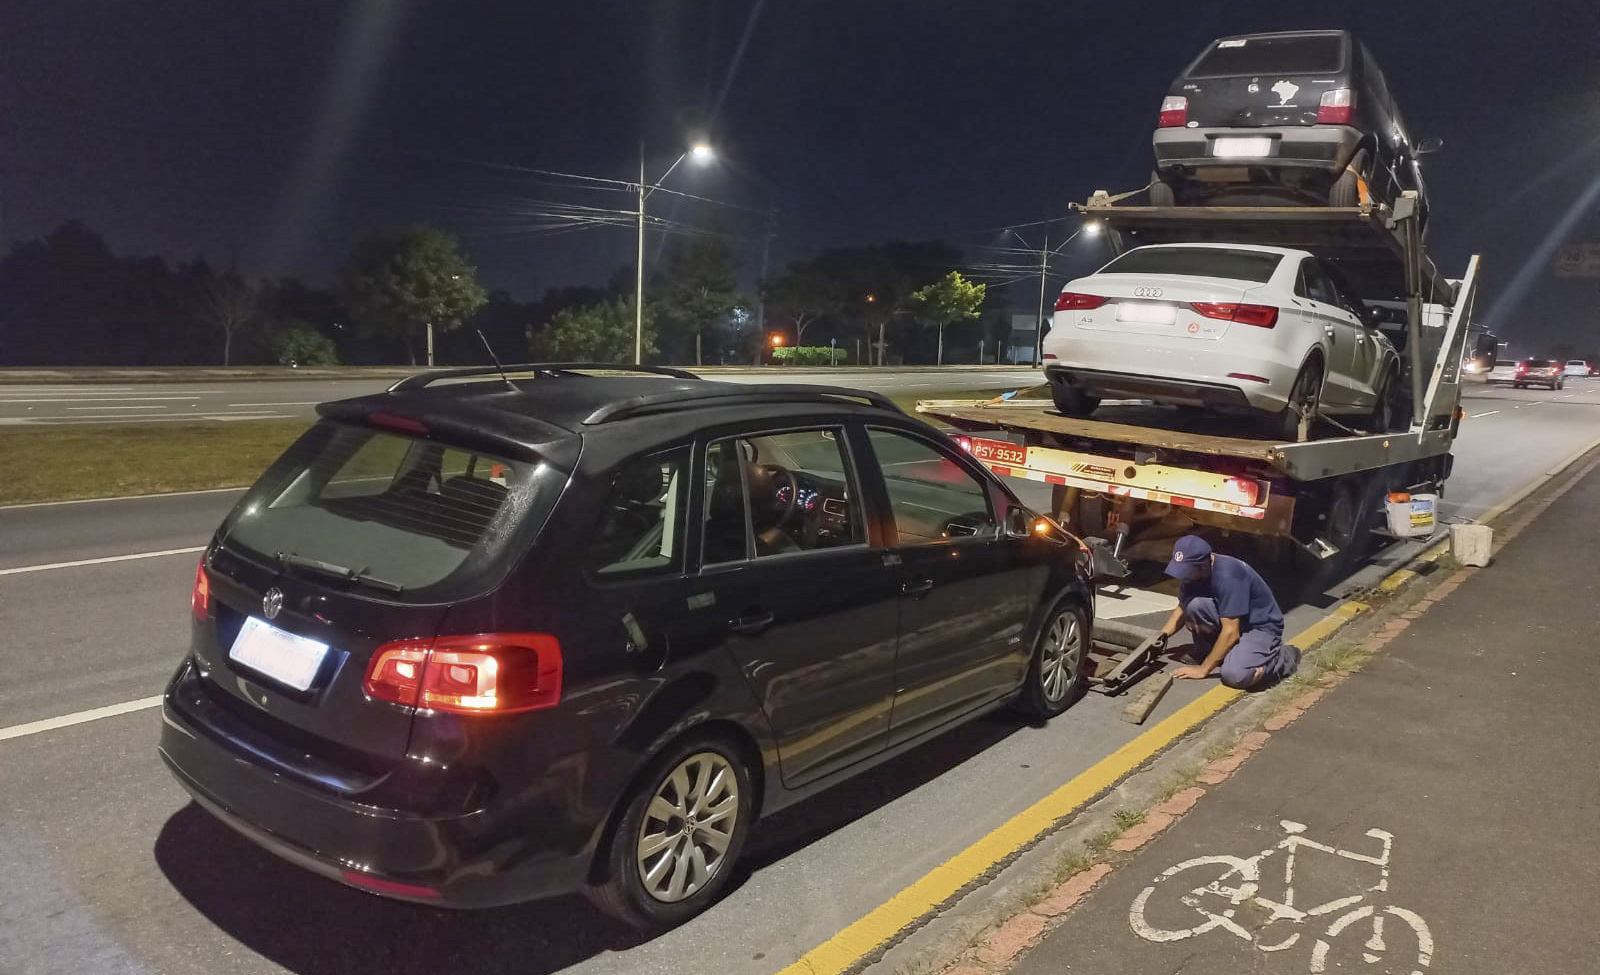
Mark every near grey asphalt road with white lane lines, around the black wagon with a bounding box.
[0,378,1600,975]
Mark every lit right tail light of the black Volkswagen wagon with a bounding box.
[365,632,562,714]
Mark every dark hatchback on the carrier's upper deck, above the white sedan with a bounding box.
[1150,30,1440,226]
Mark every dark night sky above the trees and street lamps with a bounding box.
[0,0,1600,344]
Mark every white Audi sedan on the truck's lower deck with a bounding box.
[1045,243,1410,440]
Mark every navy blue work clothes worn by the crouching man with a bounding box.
[1178,556,1299,690]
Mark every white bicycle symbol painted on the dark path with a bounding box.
[1128,820,1434,975]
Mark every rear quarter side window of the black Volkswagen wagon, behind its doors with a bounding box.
[589,447,690,575]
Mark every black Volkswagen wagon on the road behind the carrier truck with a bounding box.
[160,363,1093,925]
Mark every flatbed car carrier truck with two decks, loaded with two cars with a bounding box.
[917,191,1478,576]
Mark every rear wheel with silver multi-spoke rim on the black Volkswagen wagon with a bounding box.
[584,735,754,930]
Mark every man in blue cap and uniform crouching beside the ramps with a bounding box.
[1162,535,1299,690]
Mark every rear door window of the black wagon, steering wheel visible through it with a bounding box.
[704,427,867,565]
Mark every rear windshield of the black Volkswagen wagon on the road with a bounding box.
[222,423,565,599]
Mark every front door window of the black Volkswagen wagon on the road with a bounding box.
[867,429,997,546]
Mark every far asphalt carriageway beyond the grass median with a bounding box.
[0,367,1042,426]
